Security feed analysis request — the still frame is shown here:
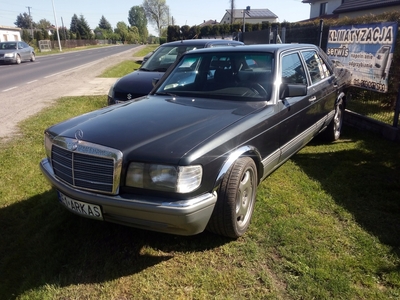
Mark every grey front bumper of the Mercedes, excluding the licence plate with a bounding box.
[40,158,217,235]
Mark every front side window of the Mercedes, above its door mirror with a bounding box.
[282,53,307,84]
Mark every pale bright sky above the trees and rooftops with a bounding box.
[0,0,310,35]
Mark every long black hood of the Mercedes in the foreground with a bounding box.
[47,95,266,164]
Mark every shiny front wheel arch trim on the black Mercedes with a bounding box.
[213,145,263,191]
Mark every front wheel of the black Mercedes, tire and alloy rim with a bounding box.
[207,157,258,238]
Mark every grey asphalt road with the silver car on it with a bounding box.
[0,45,138,92]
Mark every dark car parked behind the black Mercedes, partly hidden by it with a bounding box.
[108,39,243,105]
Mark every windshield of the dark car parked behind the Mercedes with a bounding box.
[140,45,202,72]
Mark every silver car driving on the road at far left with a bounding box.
[0,41,36,64]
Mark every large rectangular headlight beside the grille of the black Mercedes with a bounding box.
[126,163,203,193]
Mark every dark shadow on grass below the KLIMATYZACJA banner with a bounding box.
[292,128,400,264]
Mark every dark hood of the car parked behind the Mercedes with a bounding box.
[114,70,164,95]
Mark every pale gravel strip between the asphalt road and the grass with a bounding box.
[0,46,144,142]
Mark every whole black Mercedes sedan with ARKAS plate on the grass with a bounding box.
[40,44,350,238]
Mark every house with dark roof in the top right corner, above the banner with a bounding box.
[302,0,400,19]
